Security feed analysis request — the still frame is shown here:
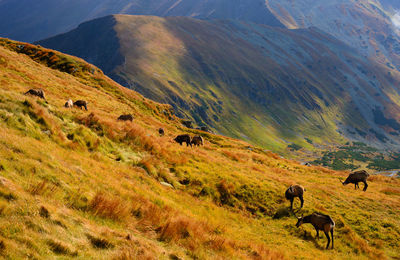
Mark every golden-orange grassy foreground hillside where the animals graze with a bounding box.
[0,39,400,259]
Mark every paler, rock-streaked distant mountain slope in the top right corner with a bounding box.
[267,0,400,69]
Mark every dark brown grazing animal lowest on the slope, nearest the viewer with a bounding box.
[296,212,335,249]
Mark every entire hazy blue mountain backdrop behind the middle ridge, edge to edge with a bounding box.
[0,0,400,72]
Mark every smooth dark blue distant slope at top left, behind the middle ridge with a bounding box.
[0,0,283,42]
